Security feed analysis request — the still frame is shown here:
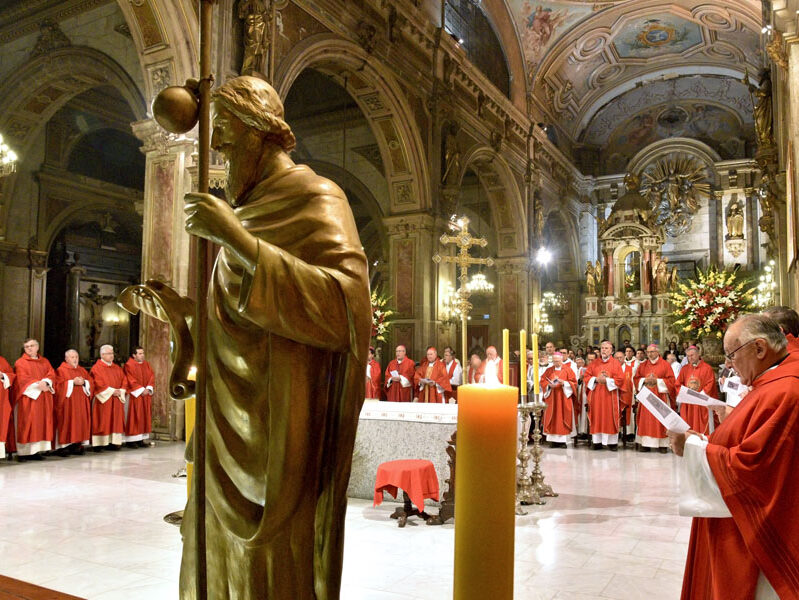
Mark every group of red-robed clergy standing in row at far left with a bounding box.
[0,339,155,461]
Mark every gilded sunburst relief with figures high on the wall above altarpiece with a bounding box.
[641,154,711,237]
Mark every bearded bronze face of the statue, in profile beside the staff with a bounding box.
[211,102,264,206]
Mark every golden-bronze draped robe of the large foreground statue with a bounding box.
[181,166,371,600]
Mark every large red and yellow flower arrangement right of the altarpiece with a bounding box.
[671,267,755,338]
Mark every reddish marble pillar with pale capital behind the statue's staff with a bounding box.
[132,119,195,432]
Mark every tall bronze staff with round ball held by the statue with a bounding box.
[153,0,216,600]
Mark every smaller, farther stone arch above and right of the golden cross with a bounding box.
[457,146,527,257]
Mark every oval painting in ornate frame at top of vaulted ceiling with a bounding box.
[613,14,702,58]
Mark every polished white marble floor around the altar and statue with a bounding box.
[0,443,690,600]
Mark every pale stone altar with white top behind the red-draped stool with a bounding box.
[347,400,458,505]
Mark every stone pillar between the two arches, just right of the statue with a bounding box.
[383,213,434,360]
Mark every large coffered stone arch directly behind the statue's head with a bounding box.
[275,34,431,214]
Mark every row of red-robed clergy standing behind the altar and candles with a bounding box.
[365,307,799,454]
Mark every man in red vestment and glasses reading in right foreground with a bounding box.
[670,315,799,600]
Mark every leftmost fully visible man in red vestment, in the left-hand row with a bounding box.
[13,339,55,460]
